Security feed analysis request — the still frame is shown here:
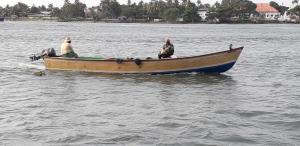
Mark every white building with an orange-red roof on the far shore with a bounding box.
[256,3,280,21]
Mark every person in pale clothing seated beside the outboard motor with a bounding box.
[60,37,78,58]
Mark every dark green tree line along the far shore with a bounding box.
[0,0,300,23]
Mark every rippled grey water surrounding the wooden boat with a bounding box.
[0,22,300,146]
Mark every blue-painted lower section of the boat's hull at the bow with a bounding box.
[151,62,235,74]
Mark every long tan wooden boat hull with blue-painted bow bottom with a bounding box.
[44,47,243,74]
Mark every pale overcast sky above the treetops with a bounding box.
[0,0,292,7]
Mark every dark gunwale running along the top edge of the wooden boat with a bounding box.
[43,46,244,62]
